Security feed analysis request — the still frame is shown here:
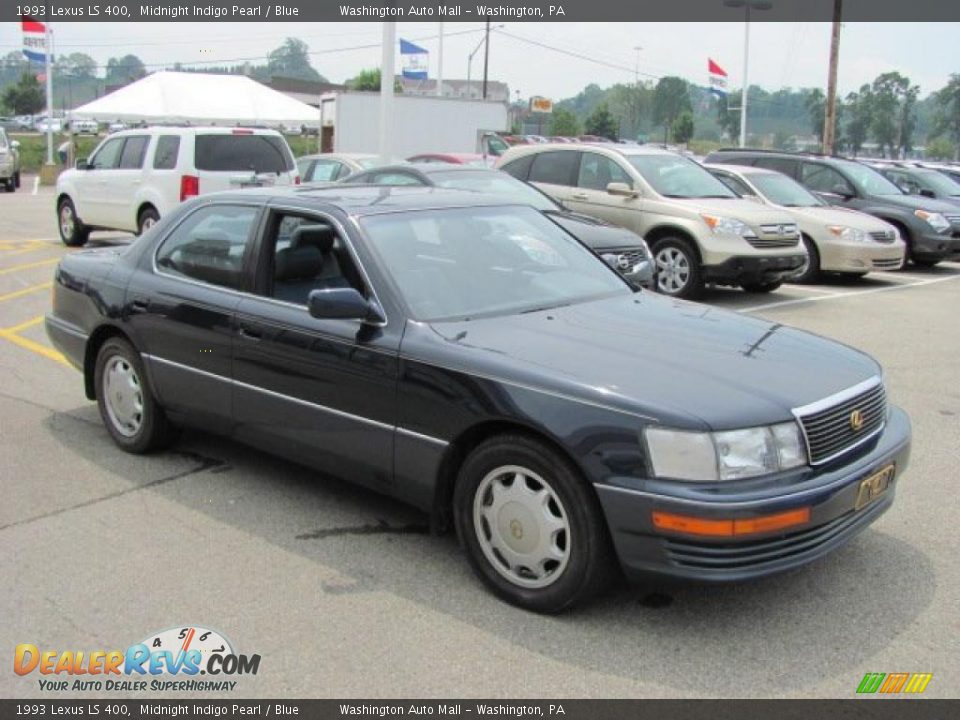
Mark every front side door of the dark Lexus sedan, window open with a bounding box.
[234,205,403,492]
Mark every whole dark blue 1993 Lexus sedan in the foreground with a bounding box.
[46,186,911,612]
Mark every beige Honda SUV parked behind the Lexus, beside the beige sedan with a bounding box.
[497,144,807,298]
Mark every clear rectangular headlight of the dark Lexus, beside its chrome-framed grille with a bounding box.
[644,422,807,482]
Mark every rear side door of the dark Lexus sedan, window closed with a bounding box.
[124,200,261,432]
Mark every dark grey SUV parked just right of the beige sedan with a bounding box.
[705,149,960,266]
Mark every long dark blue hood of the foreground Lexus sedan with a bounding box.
[403,292,880,430]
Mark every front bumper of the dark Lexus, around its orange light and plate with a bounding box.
[595,408,911,581]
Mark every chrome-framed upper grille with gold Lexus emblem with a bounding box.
[799,383,887,465]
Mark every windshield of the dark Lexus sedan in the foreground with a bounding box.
[360,206,632,322]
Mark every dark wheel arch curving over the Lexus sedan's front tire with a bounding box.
[430,418,593,534]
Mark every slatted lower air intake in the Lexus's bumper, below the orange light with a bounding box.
[664,510,858,570]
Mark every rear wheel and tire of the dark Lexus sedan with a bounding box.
[94,337,174,454]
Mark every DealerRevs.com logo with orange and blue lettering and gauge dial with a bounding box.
[13,625,260,692]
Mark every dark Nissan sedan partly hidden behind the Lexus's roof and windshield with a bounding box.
[343,164,656,289]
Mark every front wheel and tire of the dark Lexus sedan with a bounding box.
[453,435,614,613]
